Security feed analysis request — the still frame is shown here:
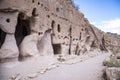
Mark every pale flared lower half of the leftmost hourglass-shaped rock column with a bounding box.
[0,34,19,62]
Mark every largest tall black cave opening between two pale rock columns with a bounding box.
[15,13,30,46]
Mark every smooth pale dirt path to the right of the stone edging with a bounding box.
[34,54,110,80]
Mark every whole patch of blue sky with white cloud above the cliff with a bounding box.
[74,0,120,34]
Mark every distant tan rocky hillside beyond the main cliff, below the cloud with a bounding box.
[92,25,120,51]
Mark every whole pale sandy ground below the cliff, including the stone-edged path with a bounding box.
[0,52,110,80]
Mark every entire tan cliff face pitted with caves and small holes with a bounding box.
[0,0,107,62]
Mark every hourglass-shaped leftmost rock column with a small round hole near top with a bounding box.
[0,11,19,62]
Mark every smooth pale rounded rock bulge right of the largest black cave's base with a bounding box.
[20,33,39,59]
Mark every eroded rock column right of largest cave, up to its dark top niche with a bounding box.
[20,8,40,59]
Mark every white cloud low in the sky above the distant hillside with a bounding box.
[92,18,120,34]
